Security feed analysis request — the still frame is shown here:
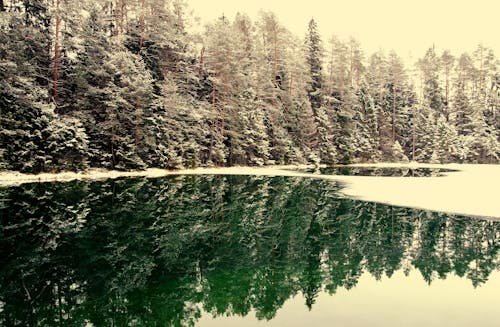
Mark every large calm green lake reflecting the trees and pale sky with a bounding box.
[0,176,500,326]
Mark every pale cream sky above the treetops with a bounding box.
[188,0,500,61]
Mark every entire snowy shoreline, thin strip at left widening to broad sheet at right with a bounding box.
[0,163,500,219]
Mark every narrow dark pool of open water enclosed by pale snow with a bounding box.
[296,166,456,177]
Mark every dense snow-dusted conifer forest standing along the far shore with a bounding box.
[0,0,500,173]
